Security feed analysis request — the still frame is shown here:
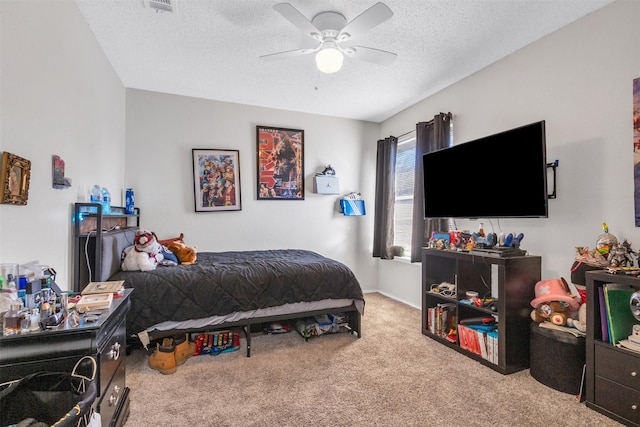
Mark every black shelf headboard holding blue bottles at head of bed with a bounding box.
[73,203,140,292]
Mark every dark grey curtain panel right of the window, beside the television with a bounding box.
[411,113,453,262]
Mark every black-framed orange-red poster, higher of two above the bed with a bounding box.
[256,126,304,200]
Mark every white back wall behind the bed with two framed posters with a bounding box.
[125,89,379,289]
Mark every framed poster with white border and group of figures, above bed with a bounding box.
[191,148,241,212]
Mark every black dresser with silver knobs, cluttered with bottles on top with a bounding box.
[0,289,132,427]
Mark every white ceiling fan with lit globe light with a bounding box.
[260,3,397,73]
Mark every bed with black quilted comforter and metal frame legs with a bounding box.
[94,228,365,356]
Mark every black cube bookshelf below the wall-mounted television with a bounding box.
[422,248,541,374]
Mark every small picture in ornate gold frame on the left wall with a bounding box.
[0,151,31,205]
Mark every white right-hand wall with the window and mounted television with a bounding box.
[378,1,640,306]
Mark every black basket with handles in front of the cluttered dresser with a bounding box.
[0,356,98,427]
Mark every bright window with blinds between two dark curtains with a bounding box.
[393,131,416,256]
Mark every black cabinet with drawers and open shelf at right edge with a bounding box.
[585,271,640,426]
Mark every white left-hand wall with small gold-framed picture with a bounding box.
[0,0,125,289]
